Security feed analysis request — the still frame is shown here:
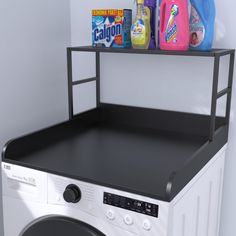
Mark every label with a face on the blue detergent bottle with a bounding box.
[190,6,205,47]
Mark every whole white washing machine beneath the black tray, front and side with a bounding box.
[2,144,225,236]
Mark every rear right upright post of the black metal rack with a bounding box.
[226,50,235,128]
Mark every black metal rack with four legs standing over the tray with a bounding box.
[67,46,235,141]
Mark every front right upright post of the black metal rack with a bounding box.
[209,55,220,141]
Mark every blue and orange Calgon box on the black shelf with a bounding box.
[92,9,132,48]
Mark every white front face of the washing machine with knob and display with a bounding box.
[2,163,168,236]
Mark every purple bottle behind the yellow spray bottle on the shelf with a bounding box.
[144,0,157,49]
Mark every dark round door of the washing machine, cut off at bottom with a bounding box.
[20,217,105,236]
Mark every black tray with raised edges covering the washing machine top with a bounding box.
[3,104,228,202]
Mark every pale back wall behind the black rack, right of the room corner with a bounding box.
[71,0,236,236]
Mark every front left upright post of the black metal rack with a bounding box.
[67,48,74,120]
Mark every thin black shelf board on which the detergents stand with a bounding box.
[68,46,235,57]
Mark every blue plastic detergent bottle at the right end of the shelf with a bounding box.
[190,0,216,51]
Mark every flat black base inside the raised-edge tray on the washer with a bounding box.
[4,121,206,200]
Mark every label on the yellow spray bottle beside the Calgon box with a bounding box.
[131,19,146,45]
